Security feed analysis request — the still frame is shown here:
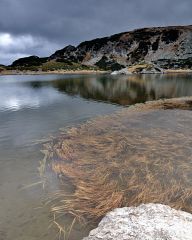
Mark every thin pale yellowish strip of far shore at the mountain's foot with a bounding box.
[0,69,192,76]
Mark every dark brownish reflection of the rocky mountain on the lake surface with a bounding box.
[53,75,192,105]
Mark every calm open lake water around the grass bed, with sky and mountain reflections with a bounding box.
[0,74,192,240]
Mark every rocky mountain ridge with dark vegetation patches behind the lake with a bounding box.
[7,25,192,70]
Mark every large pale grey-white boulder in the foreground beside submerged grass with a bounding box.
[84,204,192,240]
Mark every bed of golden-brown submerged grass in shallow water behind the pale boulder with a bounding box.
[42,98,192,232]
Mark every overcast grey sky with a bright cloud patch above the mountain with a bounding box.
[0,0,192,64]
